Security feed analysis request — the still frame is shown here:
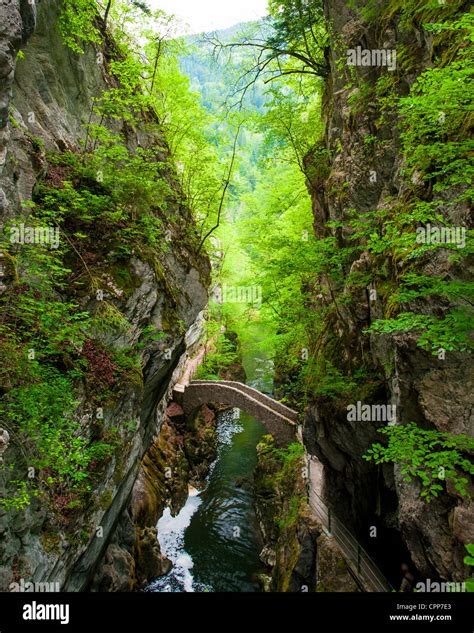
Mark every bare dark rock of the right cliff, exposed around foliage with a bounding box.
[304,0,474,582]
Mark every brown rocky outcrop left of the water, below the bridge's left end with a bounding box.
[90,403,217,591]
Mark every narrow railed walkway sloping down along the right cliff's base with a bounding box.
[309,490,393,593]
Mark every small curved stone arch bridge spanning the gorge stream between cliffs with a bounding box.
[173,380,298,447]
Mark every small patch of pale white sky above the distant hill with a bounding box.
[148,0,268,34]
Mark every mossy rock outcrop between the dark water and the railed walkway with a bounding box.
[255,436,360,593]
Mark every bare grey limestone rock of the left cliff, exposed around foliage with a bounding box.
[0,0,210,591]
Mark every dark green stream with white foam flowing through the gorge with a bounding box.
[147,332,273,592]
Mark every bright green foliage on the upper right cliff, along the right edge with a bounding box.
[360,9,474,354]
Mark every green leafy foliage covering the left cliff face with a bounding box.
[0,0,198,513]
